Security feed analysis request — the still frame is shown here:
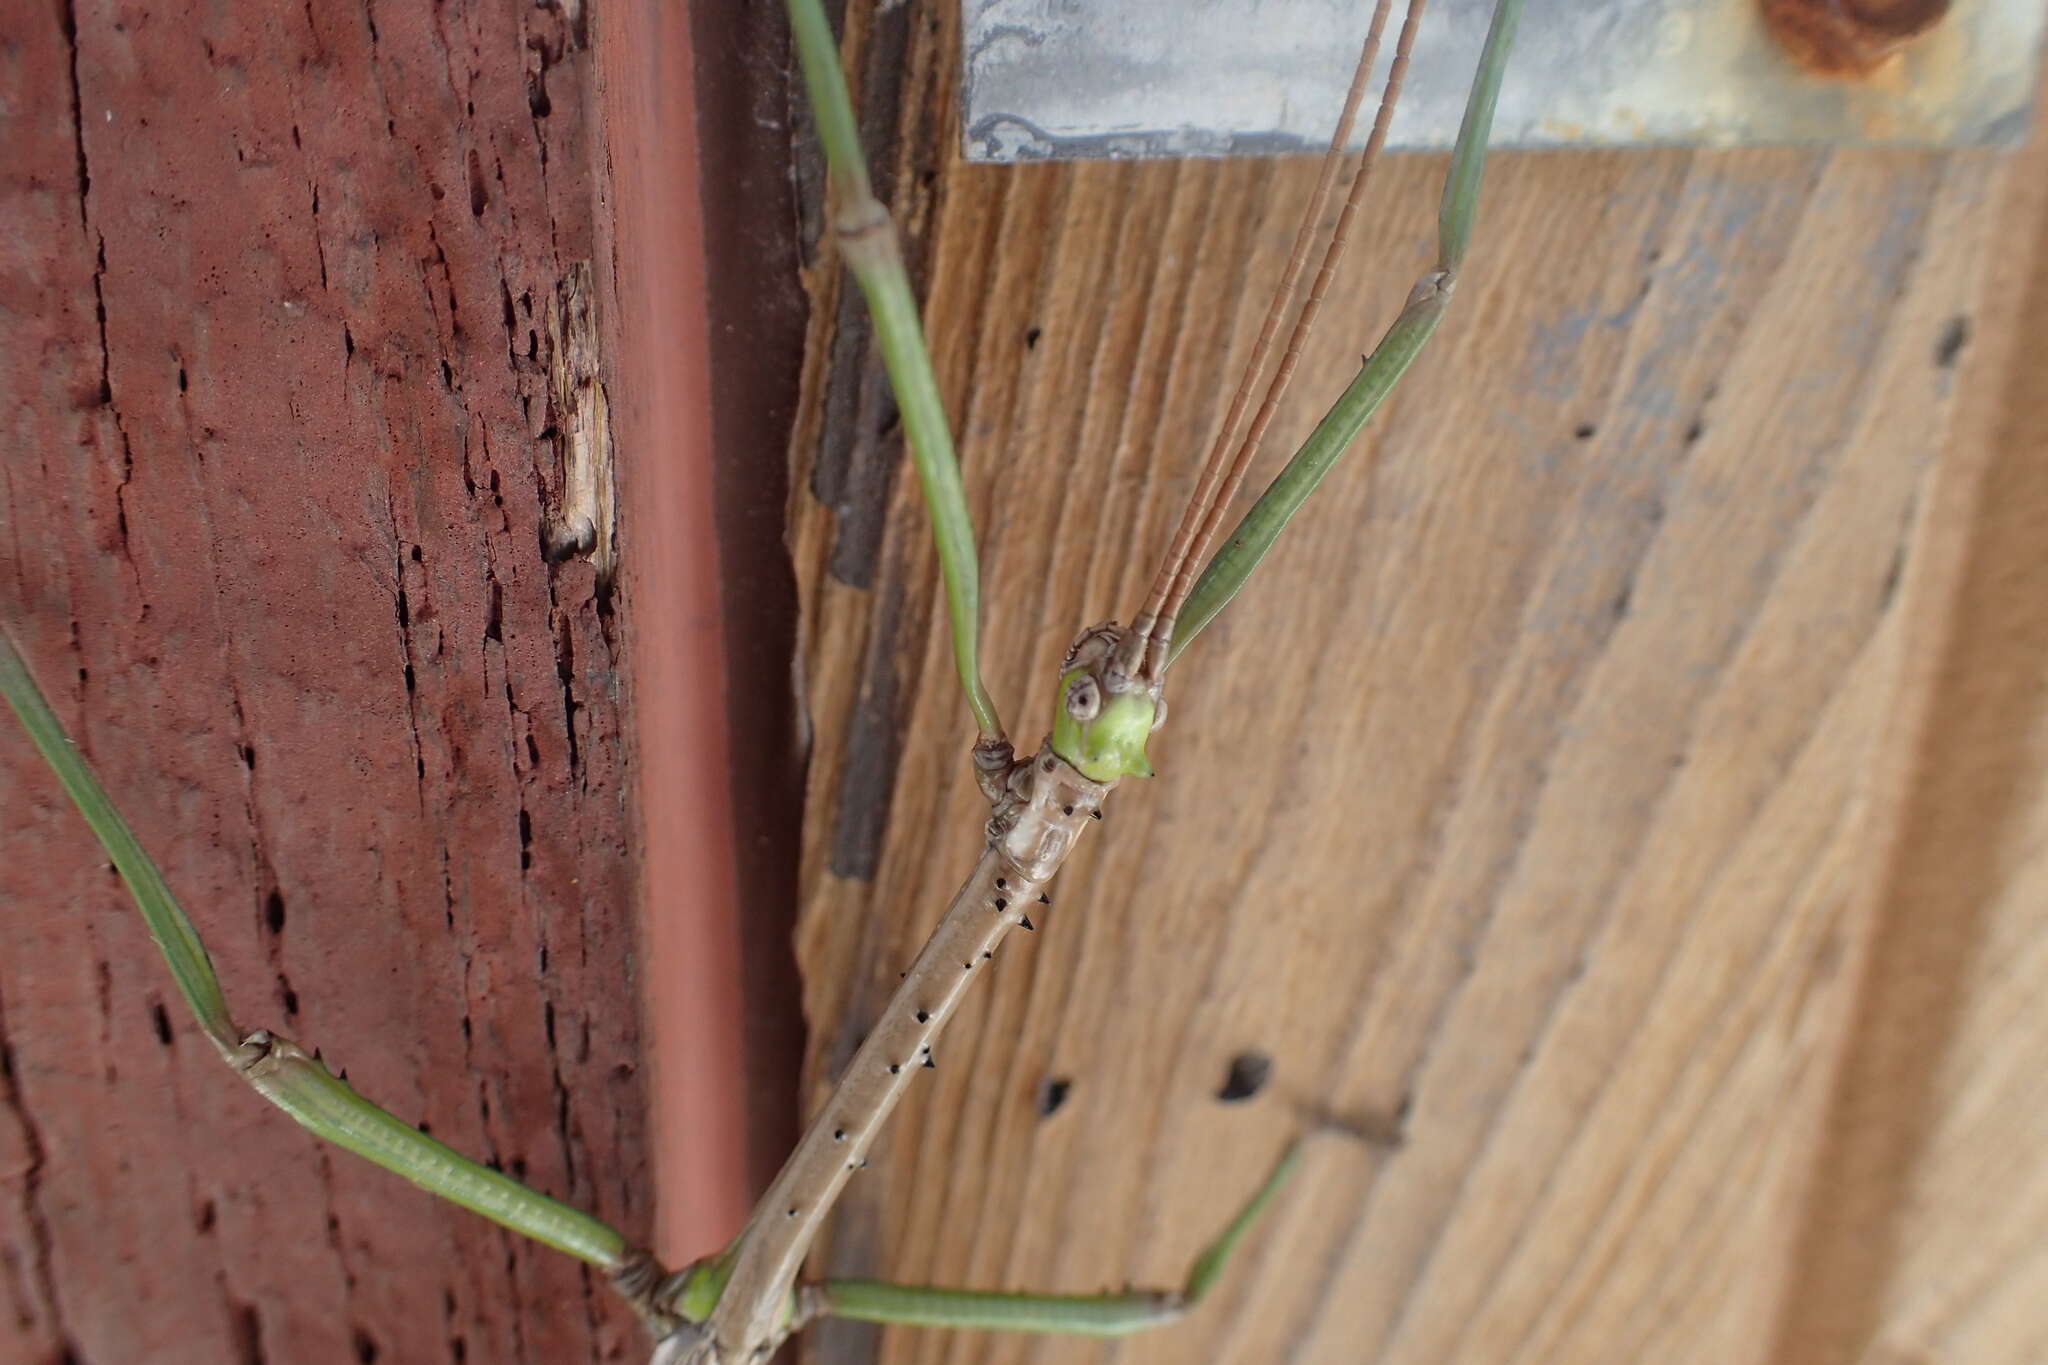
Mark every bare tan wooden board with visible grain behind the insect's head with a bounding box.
[793,4,2048,1365]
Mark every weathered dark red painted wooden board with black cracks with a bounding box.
[0,2,649,1365]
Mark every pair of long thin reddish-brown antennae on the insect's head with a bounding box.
[1116,0,1425,681]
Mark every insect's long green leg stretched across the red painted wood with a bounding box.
[0,634,643,1277]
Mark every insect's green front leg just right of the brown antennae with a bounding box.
[1174,0,1522,657]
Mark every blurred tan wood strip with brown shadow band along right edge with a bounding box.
[1776,82,2048,1365]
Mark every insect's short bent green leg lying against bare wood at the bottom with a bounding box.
[797,1142,1300,1336]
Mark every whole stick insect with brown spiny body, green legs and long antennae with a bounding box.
[0,0,1520,1365]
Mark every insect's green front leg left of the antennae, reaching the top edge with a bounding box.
[788,0,1008,749]
